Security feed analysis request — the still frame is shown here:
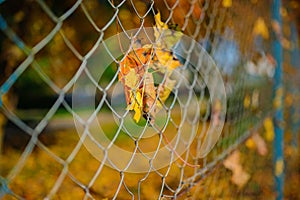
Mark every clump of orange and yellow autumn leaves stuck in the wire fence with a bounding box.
[118,12,182,123]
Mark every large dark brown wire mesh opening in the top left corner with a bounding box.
[1,1,55,46]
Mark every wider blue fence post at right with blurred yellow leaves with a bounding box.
[272,0,284,200]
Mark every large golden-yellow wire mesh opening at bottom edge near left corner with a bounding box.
[7,145,63,199]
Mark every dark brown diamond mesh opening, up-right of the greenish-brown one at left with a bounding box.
[56,5,99,55]
